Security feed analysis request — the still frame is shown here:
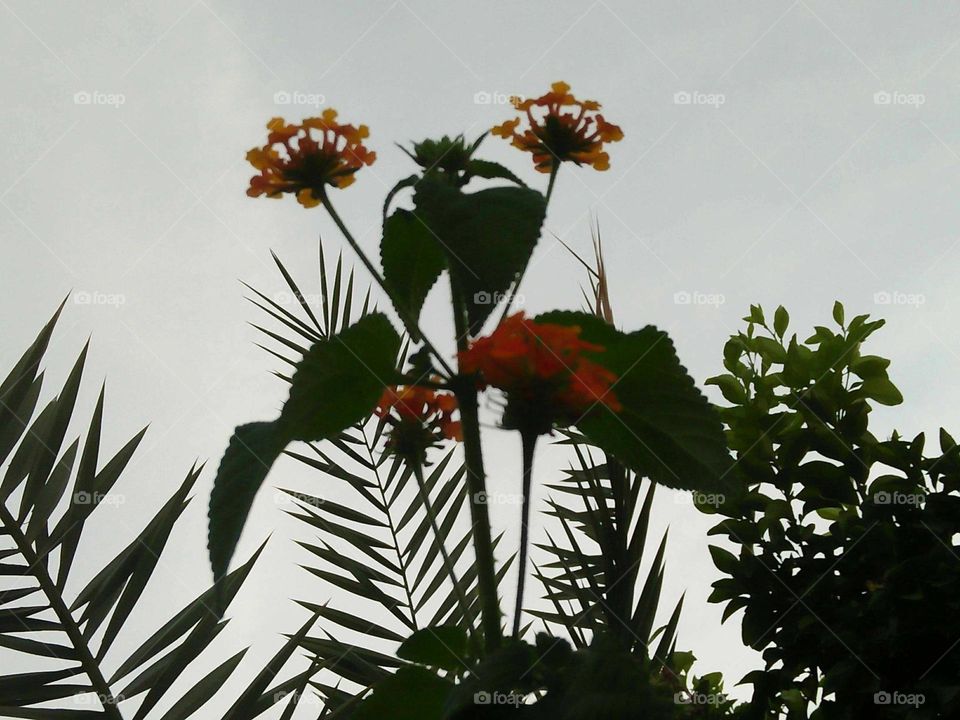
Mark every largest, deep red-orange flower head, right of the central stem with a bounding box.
[460,313,622,434]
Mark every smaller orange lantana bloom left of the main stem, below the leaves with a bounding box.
[376,385,463,464]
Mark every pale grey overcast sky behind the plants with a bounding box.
[0,0,960,716]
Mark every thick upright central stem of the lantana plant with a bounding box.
[450,276,502,652]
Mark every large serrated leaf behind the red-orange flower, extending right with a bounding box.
[537,312,733,491]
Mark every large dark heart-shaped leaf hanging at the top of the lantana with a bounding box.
[414,180,546,334]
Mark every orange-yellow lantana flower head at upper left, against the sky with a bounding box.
[247,109,377,207]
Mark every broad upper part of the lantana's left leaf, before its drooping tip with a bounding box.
[280,313,400,442]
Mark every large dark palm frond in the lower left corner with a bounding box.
[0,305,284,720]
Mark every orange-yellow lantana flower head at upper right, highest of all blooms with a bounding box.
[491,82,623,173]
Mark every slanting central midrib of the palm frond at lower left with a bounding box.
[0,505,123,720]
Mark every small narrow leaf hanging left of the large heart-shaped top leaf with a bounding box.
[380,210,447,342]
